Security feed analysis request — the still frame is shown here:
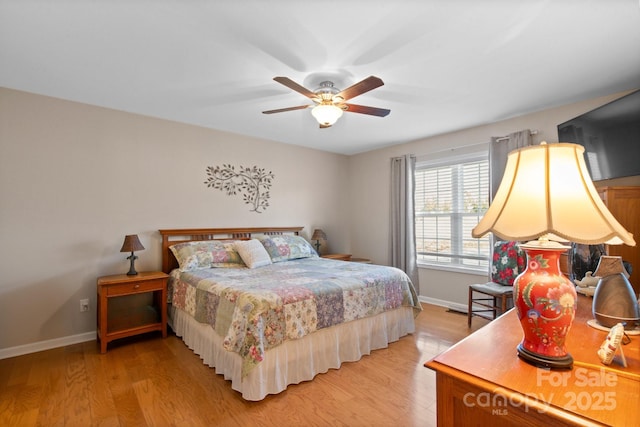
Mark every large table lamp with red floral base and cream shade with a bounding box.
[471,142,635,369]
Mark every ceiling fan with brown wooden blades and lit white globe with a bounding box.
[262,76,391,129]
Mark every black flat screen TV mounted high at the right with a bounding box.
[558,90,640,181]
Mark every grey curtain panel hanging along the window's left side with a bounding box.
[391,154,420,295]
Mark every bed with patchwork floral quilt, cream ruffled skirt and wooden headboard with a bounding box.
[159,227,422,401]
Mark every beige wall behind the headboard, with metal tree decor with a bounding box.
[0,88,350,357]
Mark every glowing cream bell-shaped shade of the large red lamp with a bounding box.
[471,142,635,246]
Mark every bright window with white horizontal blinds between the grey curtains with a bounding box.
[415,154,490,271]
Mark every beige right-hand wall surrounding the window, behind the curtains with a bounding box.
[349,92,640,308]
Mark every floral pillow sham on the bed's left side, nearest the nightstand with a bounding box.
[169,240,245,271]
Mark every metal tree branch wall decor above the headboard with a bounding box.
[204,165,275,213]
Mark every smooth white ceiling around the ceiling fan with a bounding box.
[0,0,640,154]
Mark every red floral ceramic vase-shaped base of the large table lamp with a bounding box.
[513,242,578,369]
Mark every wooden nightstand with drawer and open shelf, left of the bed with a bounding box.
[98,271,169,353]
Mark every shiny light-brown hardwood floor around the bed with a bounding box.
[0,304,487,427]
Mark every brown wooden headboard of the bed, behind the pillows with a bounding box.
[158,227,304,274]
